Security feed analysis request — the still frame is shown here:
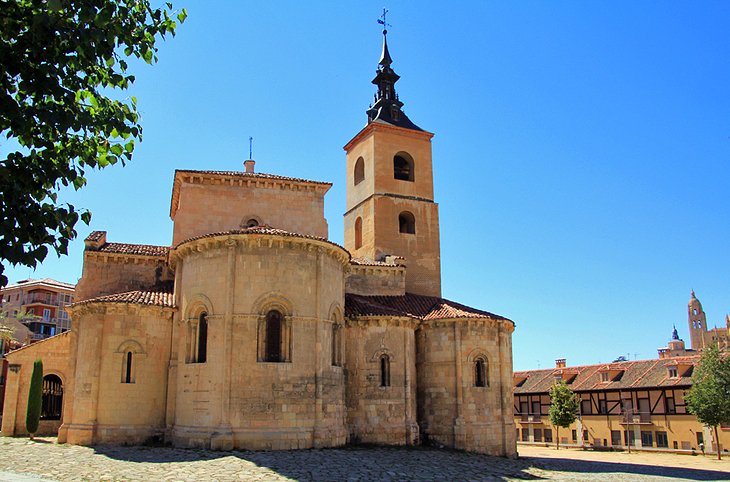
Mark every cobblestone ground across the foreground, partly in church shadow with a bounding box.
[0,437,730,482]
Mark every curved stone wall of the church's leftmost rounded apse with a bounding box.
[59,303,173,445]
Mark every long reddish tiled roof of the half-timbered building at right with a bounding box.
[514,355,699,394]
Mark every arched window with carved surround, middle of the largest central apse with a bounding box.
[253,292,293,363]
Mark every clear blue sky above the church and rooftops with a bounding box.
[0,1,730,369]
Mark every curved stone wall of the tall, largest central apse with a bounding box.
[171,234,349,449]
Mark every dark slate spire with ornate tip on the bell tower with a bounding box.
[367,9,422,131]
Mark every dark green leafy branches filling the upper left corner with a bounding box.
[0,0,187,287]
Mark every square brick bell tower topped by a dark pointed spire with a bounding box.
[345,30,441,297]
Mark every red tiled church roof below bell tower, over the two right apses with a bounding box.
[345,293,510,321]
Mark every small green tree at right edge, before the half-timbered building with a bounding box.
[684,344,730,460]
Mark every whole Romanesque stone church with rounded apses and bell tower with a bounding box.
[2,32,516,456]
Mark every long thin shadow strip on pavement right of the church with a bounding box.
[520,457,730,481]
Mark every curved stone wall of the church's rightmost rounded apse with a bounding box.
[417,319,516,456]
